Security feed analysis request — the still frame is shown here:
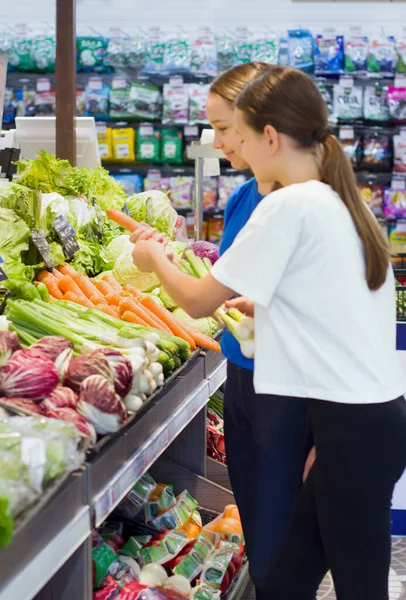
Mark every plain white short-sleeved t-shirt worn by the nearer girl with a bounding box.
[212,181,406,404]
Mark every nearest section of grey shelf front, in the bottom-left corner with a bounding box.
[0,470,91,600]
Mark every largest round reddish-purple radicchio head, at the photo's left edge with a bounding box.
[0,350,59,401]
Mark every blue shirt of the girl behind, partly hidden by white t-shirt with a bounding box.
[220,179,263,371]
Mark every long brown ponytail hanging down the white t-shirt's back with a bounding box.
[320,135,390,291]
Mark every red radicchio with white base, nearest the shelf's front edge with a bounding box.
[77,375,126,434]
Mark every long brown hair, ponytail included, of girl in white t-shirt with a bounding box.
[236,67,390,290]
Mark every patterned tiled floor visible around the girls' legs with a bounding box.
[246,538,406,600]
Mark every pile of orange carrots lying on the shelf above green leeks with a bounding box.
[37,264,220,352]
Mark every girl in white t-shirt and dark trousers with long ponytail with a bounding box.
[133,67,406,600]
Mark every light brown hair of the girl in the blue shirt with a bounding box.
[209,61,271,105]
